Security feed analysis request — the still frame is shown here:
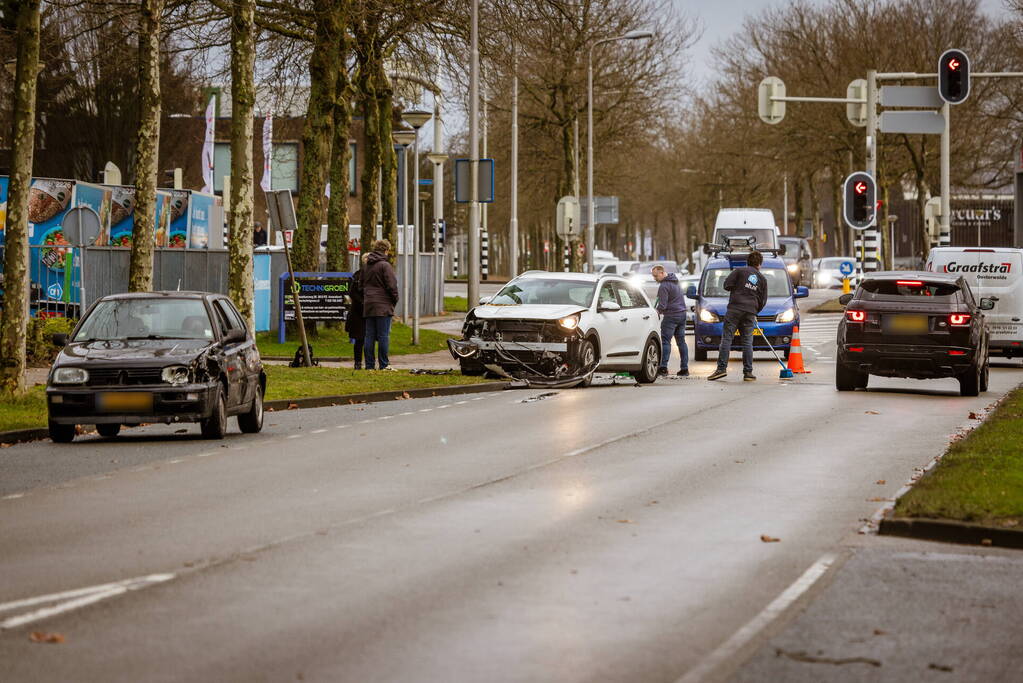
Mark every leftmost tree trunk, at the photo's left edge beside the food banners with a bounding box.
[0,0,39,394]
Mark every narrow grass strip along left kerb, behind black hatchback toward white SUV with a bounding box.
[0,365,489,431]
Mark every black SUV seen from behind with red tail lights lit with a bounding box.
[835,272,993,396]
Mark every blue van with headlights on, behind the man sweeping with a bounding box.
[685,253,810,361]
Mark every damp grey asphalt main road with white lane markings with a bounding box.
[0,316,1023,681]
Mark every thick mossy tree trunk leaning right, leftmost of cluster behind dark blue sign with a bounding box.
[292,6,345,271]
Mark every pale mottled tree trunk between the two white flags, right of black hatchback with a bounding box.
[227,0,256,333]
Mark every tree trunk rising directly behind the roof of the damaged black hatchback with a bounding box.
[128,0,165,291]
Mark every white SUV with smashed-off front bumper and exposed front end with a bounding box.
[448,271,661,386]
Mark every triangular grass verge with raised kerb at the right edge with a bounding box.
[895,389,1023,527]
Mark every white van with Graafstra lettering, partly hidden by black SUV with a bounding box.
[926,246,1023,358]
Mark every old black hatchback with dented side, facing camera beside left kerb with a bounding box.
[46,291,266,443]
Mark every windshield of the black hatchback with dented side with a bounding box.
[72,298,213,342]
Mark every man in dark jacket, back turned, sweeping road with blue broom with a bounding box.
[707,252,767,381]
